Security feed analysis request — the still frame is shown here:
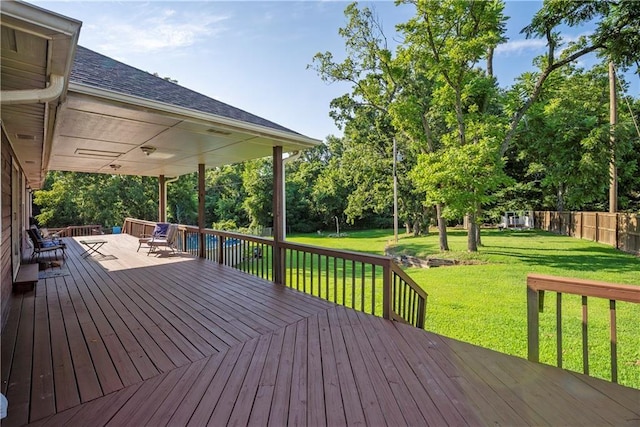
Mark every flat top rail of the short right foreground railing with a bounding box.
[527,274,640,304]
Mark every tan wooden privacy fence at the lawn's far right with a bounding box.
[534,211,640,255]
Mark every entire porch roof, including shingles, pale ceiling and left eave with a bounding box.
[1,1,321,189]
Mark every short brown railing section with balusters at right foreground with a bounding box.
[527,274,640,382]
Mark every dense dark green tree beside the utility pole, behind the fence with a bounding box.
[513,63,638,211]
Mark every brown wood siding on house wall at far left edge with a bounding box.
[0,132,13,330]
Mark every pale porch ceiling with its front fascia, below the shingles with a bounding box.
[49,82,319,176]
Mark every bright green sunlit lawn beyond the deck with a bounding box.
[289,230,640,388]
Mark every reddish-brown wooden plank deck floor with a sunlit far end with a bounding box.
[1,235,640,426]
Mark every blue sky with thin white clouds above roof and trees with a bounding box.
[30,1,640,140]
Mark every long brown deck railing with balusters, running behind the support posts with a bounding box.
[122,218,427,328]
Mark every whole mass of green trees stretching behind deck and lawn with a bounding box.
[35,0,640,247]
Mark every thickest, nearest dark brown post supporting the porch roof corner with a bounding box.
[273,146,285,285]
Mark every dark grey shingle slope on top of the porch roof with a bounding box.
[70,46,300,135]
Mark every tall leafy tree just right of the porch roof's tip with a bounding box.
[314,3,448,250]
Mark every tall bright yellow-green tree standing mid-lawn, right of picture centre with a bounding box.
[398,0,506,251]
